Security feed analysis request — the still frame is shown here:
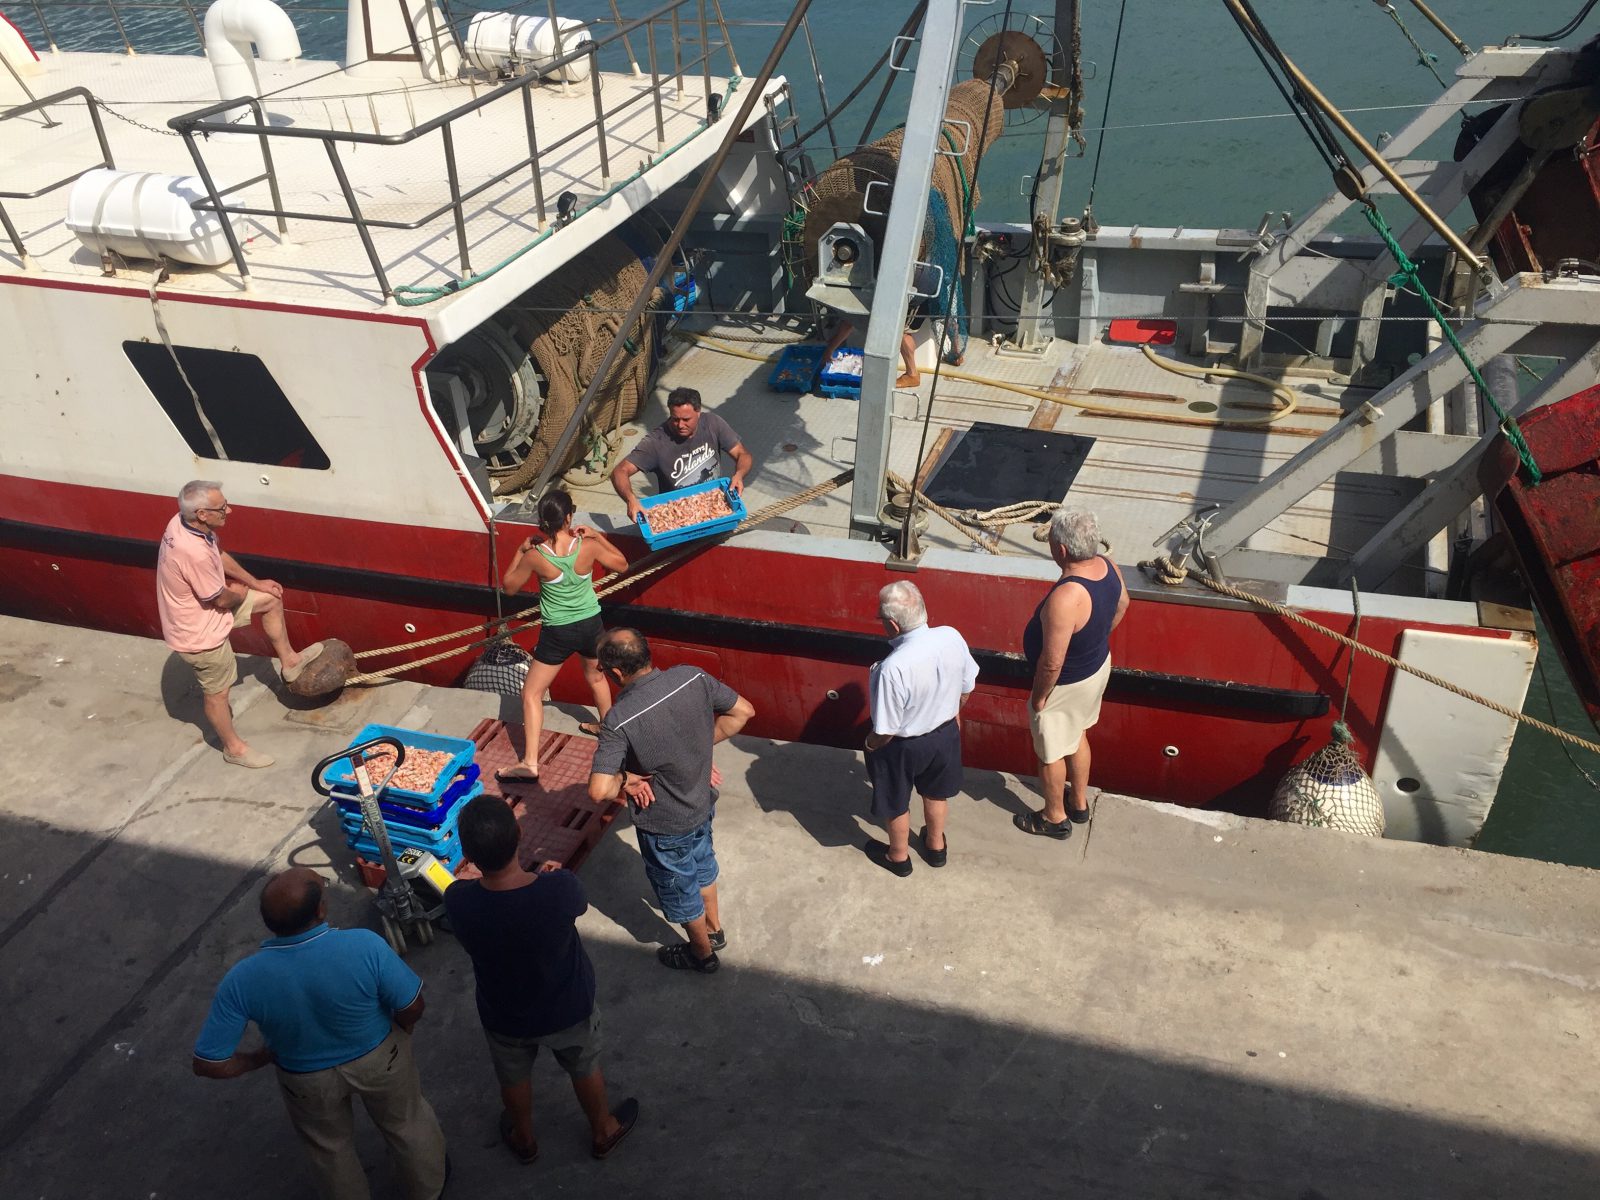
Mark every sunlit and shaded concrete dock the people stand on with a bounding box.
[0,618,1600,1200]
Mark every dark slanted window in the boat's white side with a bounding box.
[122,341,328,470]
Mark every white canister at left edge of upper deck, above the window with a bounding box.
[67,166,232,267]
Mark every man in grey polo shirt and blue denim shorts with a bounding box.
[589,629,755,974]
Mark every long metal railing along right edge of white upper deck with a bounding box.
[168,0,738,301]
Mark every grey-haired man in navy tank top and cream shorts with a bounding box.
[1013,507,1128,838]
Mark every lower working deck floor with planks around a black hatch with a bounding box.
[569,316,1421,594]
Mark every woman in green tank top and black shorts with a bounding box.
[494,488,627,782]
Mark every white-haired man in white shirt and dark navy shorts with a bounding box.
[866,581,978,878]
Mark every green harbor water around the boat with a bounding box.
[21,0,1600,867]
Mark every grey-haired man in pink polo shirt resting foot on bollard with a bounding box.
[155,480,322,766]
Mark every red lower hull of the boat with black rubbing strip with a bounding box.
[0,477,1506,813]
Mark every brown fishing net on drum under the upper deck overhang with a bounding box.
[494,234,656,496]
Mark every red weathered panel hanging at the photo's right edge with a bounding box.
[1478,387,1600,728]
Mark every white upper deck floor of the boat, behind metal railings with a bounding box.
[0,53,761,321]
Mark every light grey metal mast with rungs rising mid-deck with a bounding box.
[850,0,963,539]
